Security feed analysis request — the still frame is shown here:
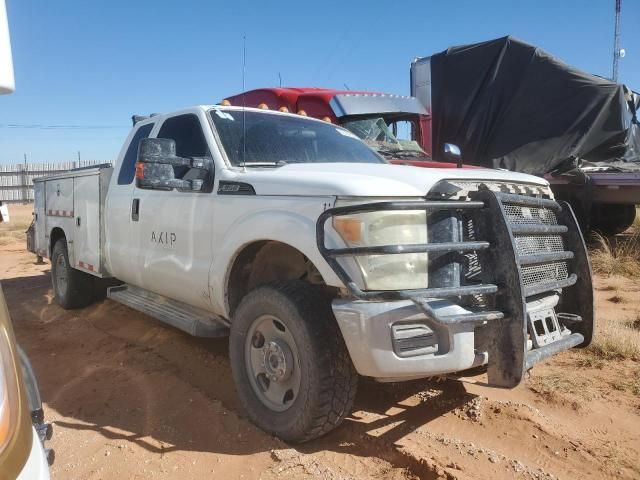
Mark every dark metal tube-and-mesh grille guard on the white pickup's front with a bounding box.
[316,189,594,388]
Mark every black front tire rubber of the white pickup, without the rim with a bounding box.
[229,281,358,443]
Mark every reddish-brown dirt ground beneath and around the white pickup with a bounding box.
[0,206,640,480]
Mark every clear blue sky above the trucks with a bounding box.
[0,0,640,163]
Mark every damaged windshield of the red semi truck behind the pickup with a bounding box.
[342,117,426,158]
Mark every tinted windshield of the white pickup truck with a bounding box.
[209,109,384,166]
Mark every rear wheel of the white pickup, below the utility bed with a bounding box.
[51,238,94,310]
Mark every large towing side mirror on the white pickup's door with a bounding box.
[136,138,208,191]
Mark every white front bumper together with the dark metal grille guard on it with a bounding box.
[317,190,594,387]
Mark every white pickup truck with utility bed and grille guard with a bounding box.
[29,106,594,442]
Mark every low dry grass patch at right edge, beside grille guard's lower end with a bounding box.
[589,317,640,360]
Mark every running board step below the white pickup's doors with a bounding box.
[107,284,229,338]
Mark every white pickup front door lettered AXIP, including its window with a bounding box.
[132,114,213,308]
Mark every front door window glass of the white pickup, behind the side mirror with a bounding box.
[157,113,213,192]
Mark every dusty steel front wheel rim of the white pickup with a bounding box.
[244,315,301,412]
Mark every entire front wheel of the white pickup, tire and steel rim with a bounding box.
[229,281,358,443]
